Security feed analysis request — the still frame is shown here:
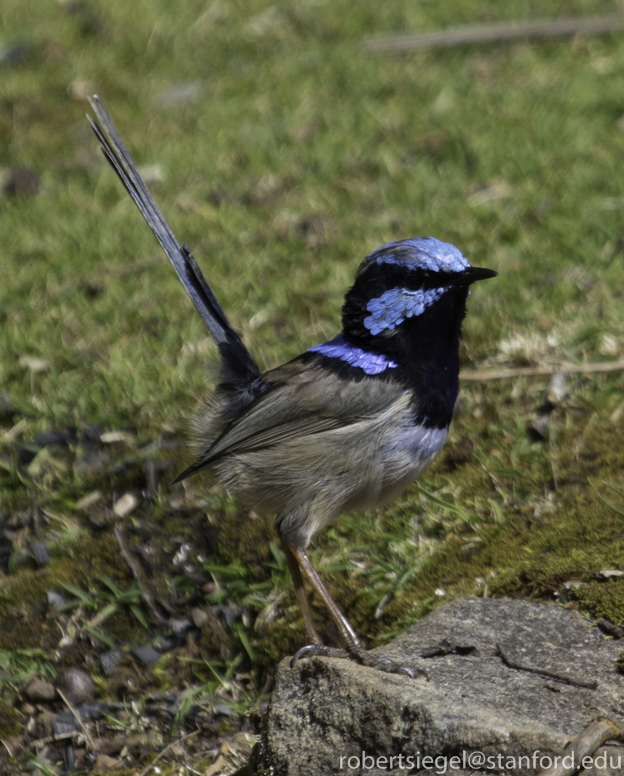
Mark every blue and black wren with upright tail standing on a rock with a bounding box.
[89,97,496,675]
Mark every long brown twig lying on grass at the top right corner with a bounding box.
[361,14,624,54]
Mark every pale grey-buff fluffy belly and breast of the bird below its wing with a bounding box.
[214,394,447,546]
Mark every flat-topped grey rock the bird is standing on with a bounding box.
[255,598,624,776]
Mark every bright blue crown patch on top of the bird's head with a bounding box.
[365,237,470,272]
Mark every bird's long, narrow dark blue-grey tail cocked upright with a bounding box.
[87,95,260,390]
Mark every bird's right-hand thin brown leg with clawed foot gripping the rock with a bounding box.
[282,539,420,677]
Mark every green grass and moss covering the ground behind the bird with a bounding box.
[0,0,624,768]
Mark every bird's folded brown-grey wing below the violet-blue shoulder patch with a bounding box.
[177,359,404,481]
